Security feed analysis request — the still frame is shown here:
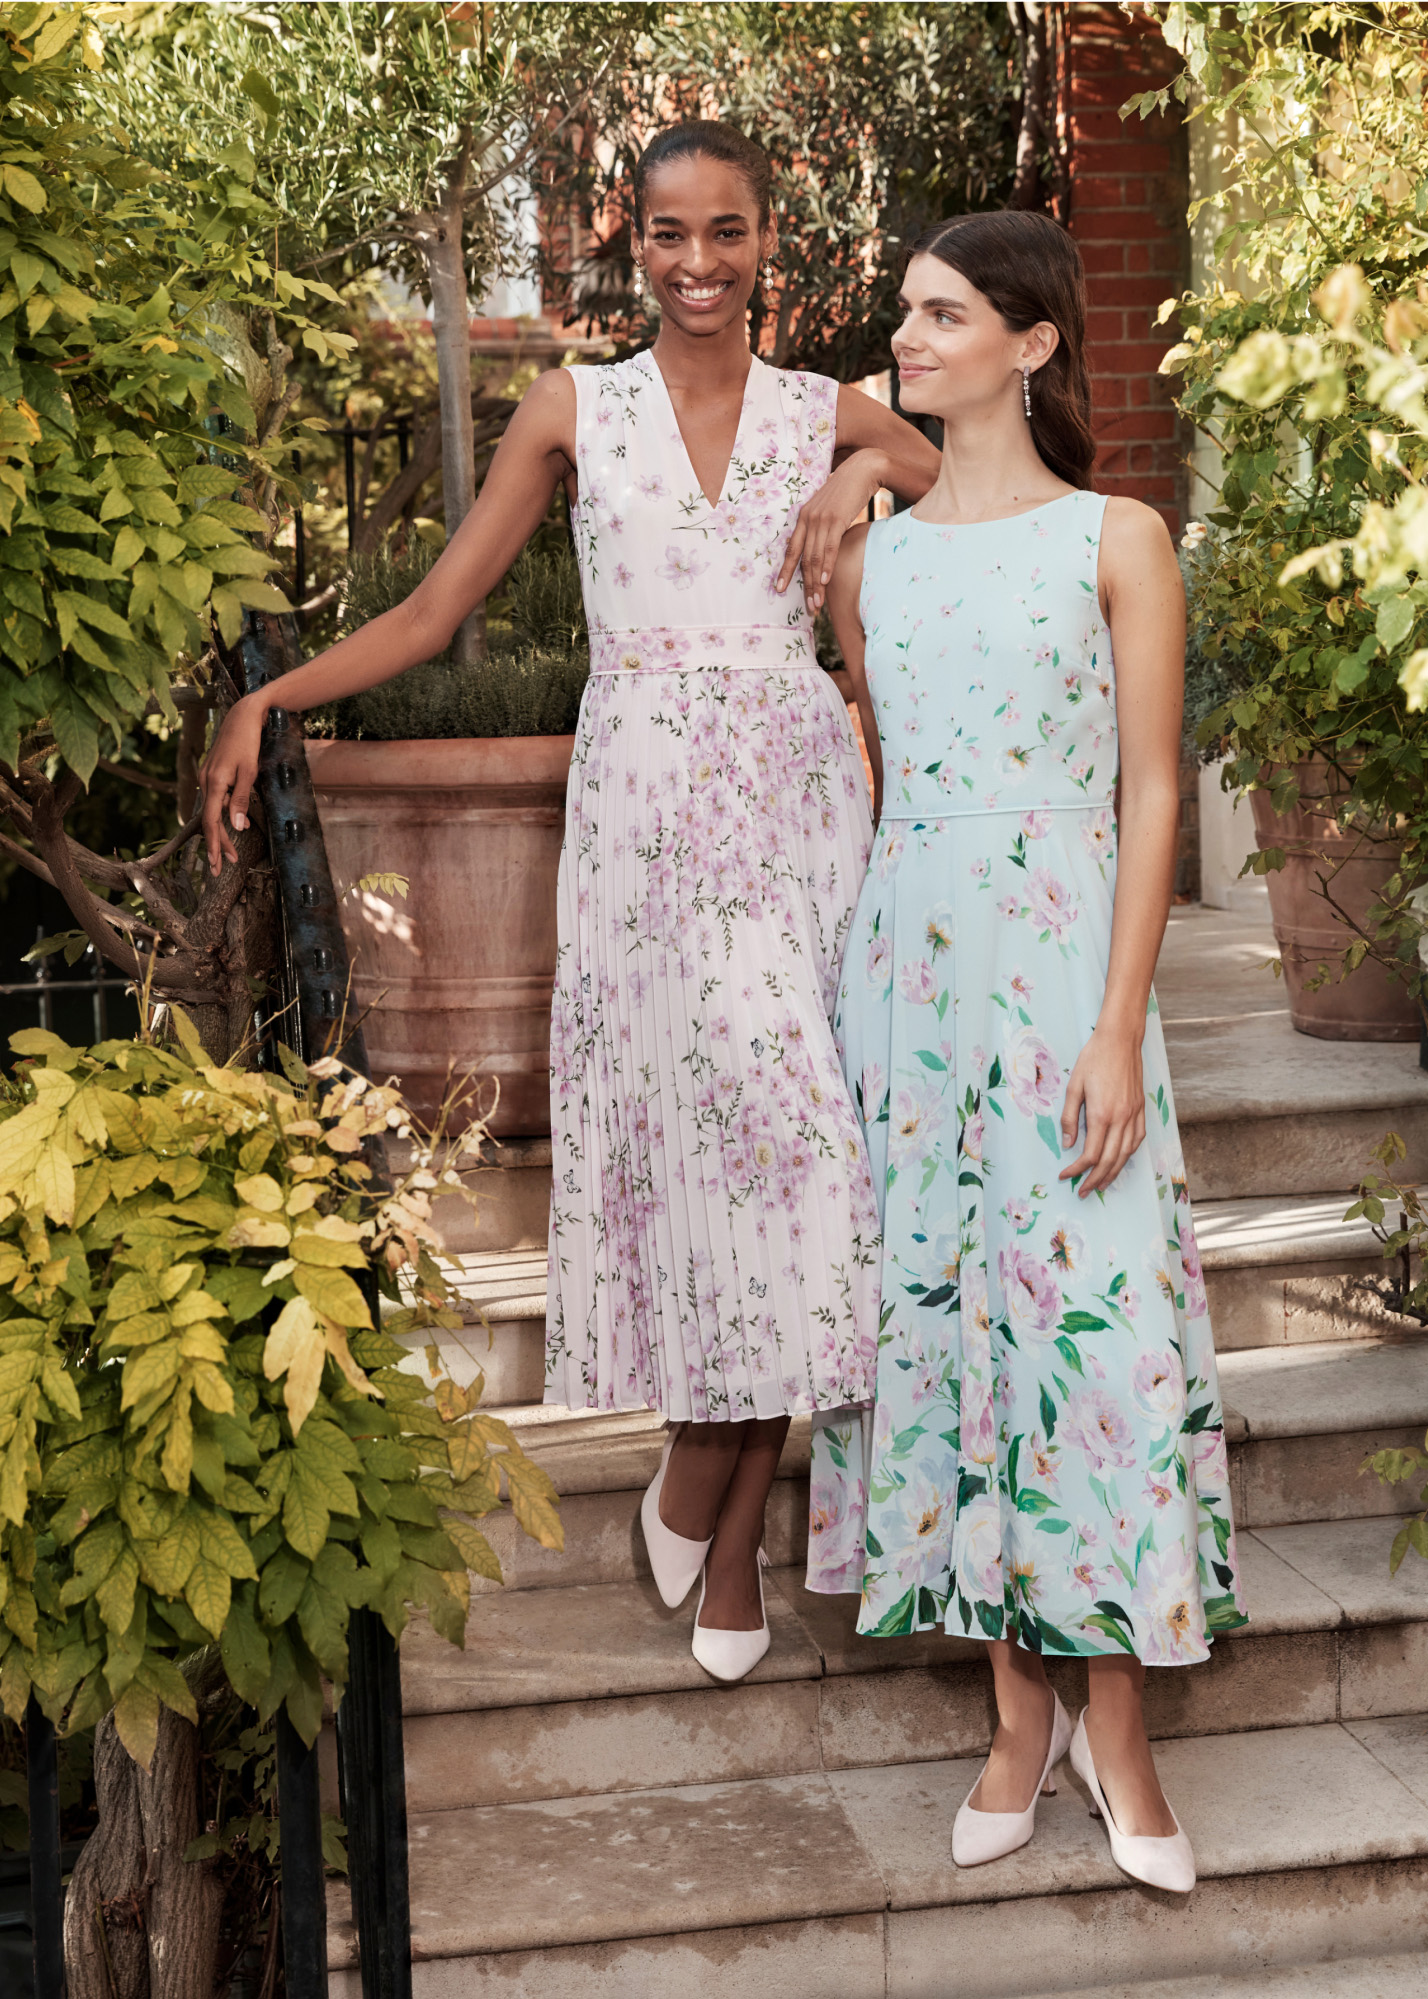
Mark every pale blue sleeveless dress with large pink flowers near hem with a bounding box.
[808,492,1246,1665]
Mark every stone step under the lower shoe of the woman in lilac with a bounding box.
[390,1521,1428,1811]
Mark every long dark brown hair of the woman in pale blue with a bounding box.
[910,208,1096,488]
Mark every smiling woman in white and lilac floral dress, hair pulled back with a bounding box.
[204,122,938,1679]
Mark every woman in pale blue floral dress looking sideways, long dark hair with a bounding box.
[808,212,1244,1891]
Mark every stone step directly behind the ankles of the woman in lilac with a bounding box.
[436,1331,1428,1591]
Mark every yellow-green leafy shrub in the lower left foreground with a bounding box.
[0,1013,560,1763]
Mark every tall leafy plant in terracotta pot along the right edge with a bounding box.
[1128,4,1428,1039]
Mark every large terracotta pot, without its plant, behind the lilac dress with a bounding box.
[308,736,574,1137]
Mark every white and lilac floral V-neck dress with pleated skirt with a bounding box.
[546,352,878,1421]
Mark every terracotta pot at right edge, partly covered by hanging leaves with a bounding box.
[1250,762,1422,1041]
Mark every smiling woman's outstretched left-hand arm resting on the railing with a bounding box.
[204,368,576,874]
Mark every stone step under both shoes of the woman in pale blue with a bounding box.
[328,1717,1428,1999]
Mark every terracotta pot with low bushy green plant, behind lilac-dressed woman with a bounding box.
[308,534,588,1137]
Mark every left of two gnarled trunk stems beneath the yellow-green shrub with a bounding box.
[64,1715,150,1999]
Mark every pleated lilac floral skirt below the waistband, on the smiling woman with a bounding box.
[546,666,880,1421]
